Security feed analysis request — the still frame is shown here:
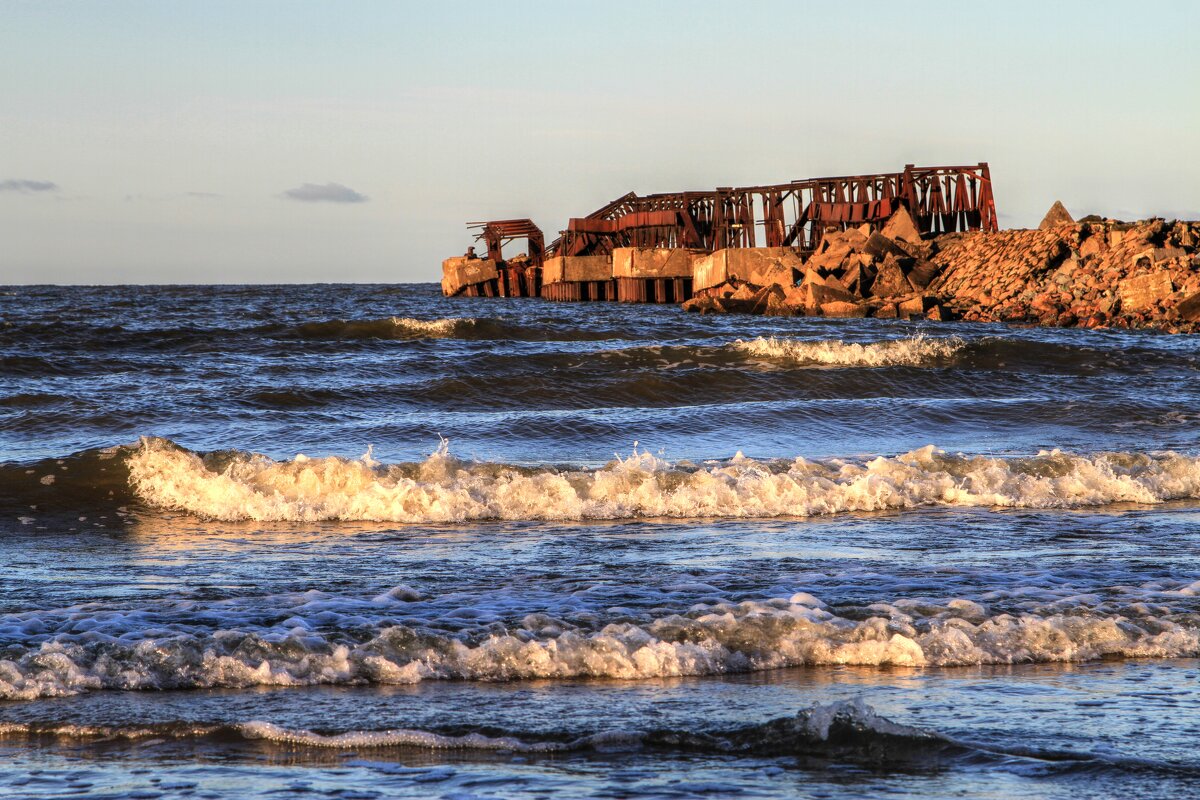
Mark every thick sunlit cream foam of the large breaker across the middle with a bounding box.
[128,439,1200,523]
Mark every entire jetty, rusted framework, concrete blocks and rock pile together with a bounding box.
[442,162,1200,331]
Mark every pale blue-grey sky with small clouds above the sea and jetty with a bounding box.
[0,0,1200,284]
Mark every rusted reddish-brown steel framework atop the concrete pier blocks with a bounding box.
[475,162,997,265]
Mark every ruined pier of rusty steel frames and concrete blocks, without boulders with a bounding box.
[442,162,997,303]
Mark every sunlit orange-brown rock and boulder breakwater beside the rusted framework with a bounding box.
[684,204,1200,332]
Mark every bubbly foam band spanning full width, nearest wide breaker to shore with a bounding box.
[0,593,1200,699]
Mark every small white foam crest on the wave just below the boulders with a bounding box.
[733,335,966,367]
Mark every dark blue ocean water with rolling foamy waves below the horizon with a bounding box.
[0,284,1200,798]
